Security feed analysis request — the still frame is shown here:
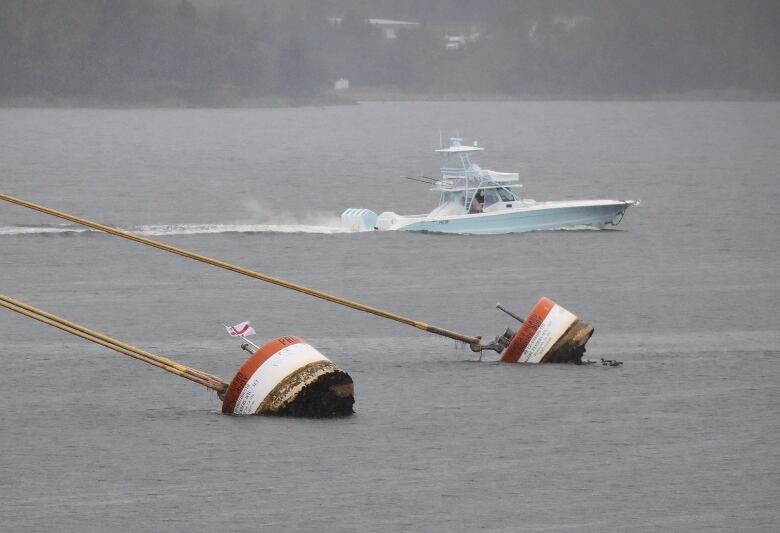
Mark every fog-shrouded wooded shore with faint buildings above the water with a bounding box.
[0,0,780,106]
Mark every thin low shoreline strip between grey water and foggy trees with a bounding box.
[0,88,780,109]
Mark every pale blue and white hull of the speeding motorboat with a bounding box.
[379,200,634,234]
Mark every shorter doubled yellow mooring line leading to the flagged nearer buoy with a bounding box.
[0,294,228,394]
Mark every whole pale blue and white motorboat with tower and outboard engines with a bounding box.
[341,137,639,234]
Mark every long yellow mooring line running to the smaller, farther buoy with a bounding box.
[0,193,481,345]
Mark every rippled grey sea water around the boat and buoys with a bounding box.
[0,102,780,532]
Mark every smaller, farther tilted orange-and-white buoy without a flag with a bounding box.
[501,298,593,363]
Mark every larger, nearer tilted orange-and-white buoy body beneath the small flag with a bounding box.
[222,336,355,417]
